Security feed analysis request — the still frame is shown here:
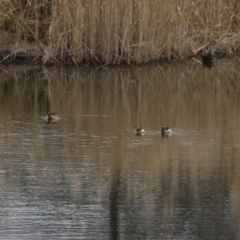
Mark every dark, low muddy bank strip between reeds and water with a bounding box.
[0,45,232,67]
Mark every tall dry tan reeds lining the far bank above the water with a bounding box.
[0,0,240,64]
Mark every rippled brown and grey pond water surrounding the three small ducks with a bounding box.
[0,60,240,239]
